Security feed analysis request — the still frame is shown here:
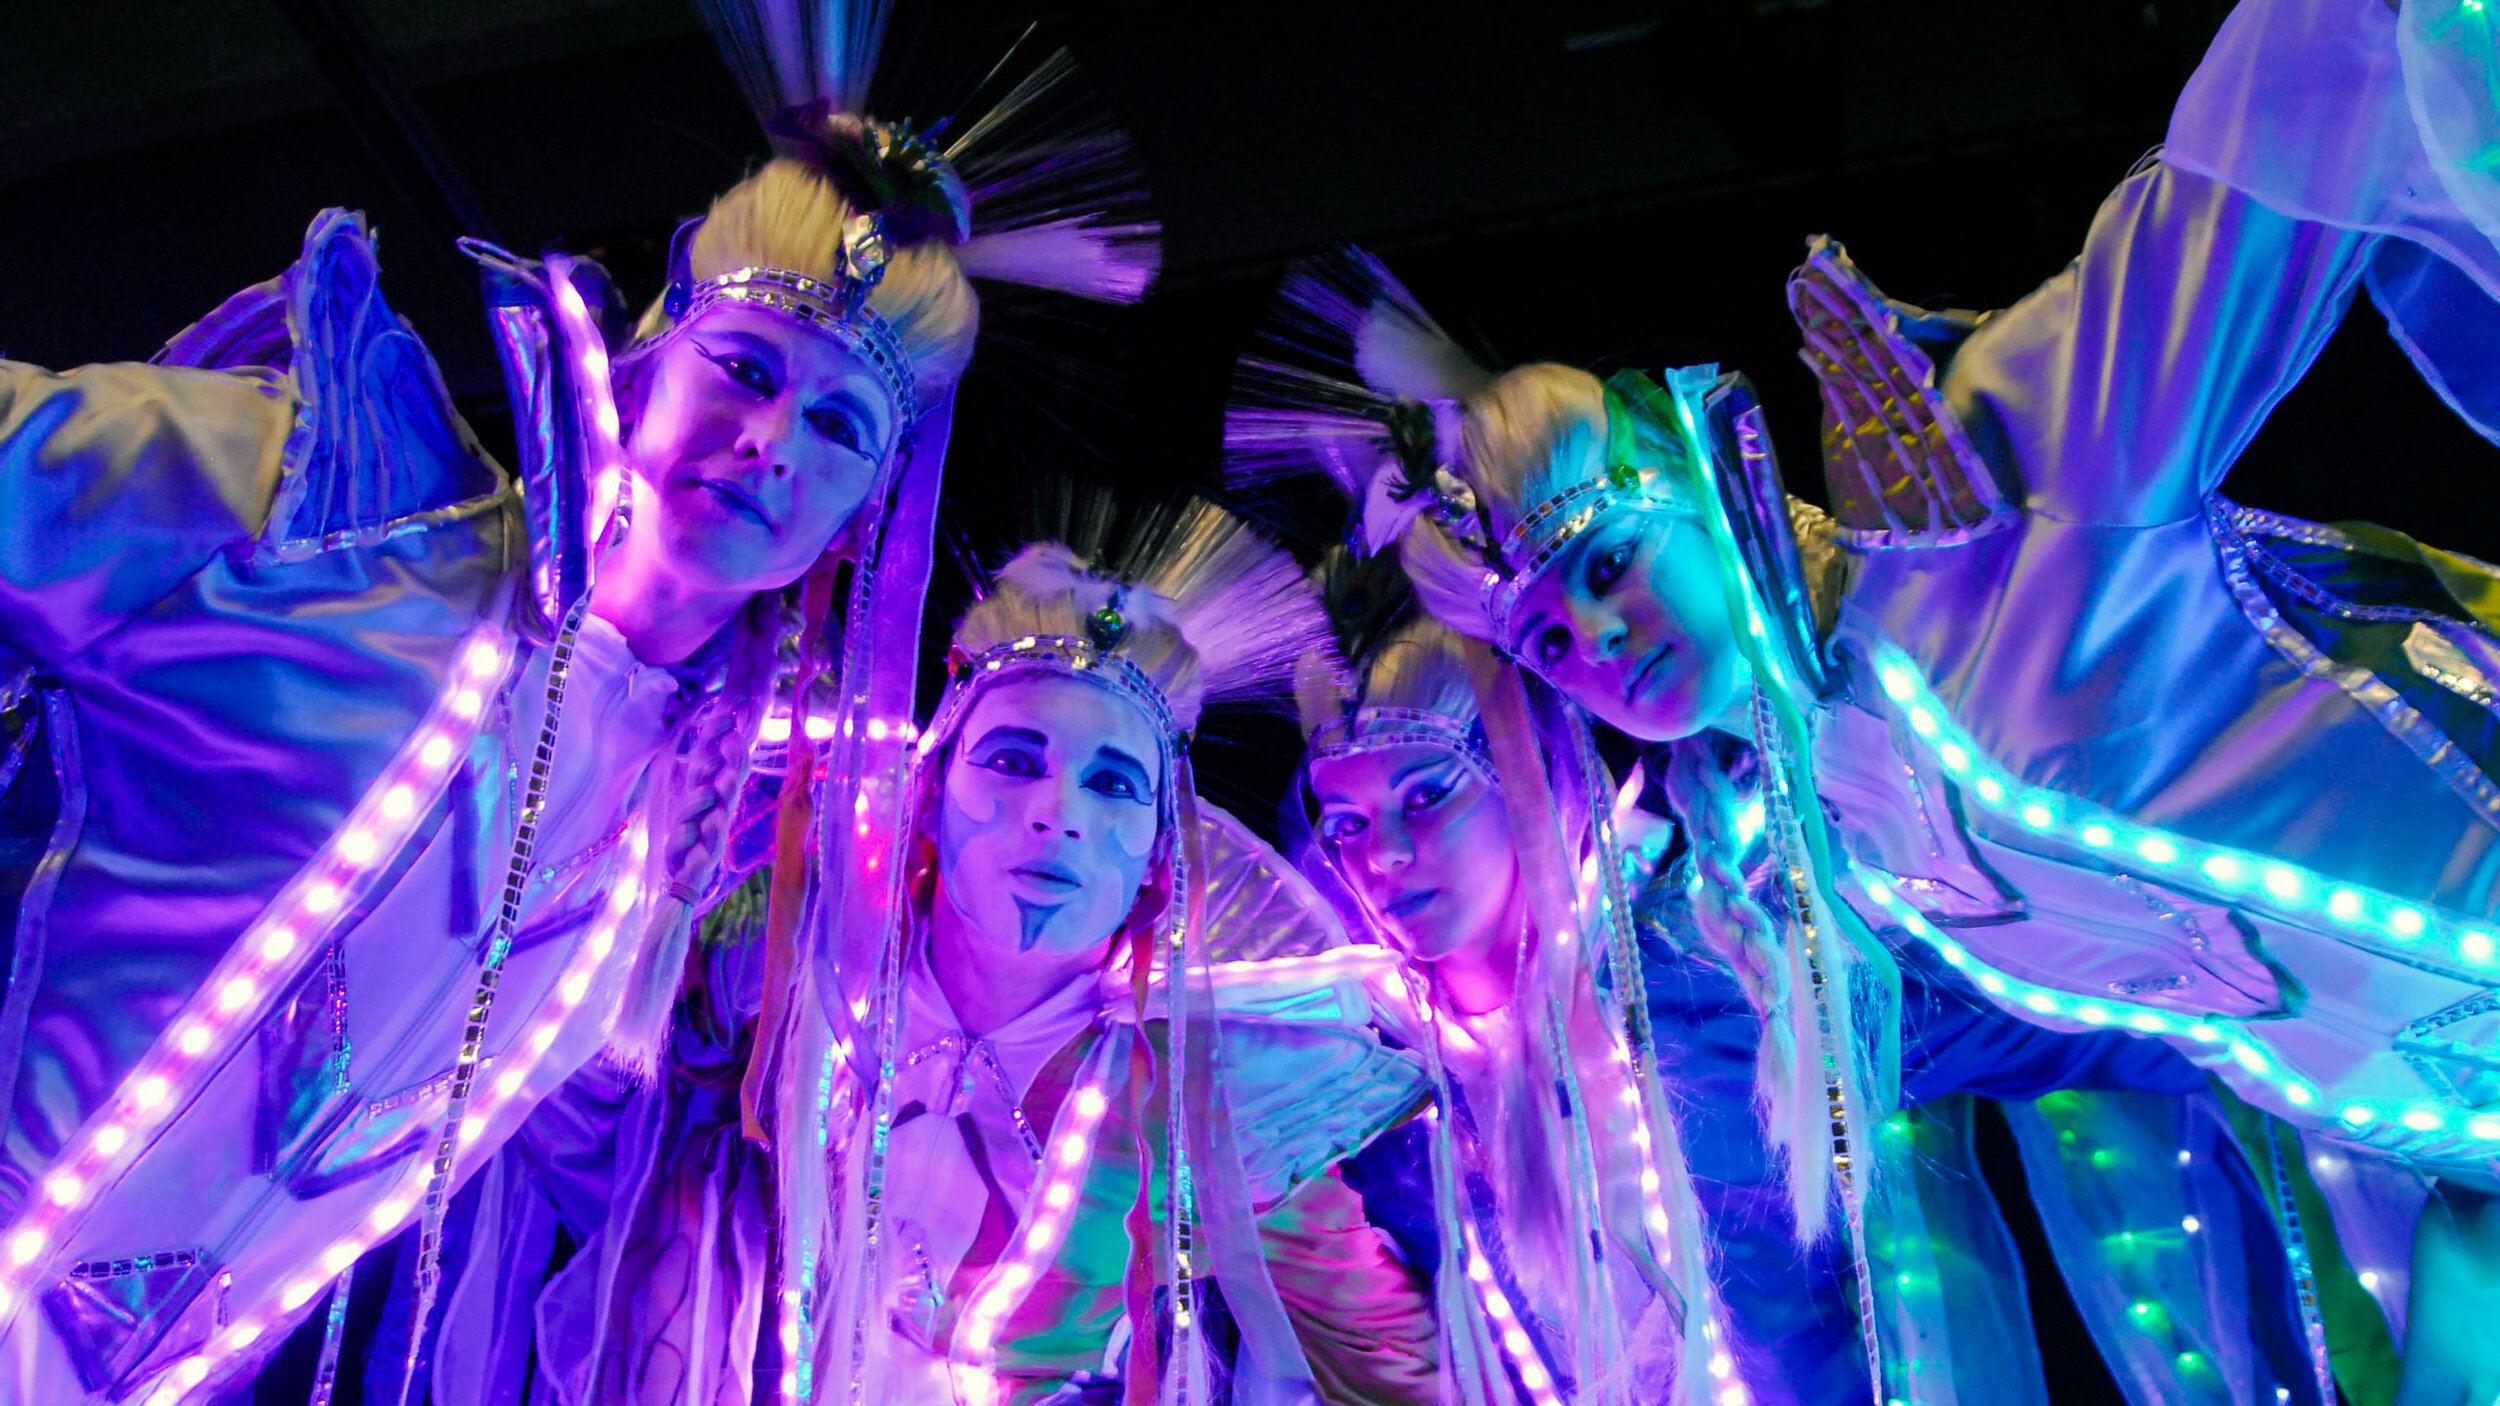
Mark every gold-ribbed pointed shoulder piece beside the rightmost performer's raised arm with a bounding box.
[1788,235,2018,548]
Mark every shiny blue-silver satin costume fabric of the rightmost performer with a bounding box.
[1800,0,2500,1401]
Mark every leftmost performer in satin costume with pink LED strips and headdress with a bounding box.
[0,0,1155,1403]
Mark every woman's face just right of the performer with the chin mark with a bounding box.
[1310,743,1520,963]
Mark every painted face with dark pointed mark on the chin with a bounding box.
[938,673,1165,956]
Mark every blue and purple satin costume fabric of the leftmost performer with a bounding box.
[0,213,680,1403]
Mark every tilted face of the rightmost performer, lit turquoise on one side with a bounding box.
[1505,505,1748,743]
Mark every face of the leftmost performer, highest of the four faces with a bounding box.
[628,303,898,593]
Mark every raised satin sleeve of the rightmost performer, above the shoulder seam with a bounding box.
[1943,0,2500,525]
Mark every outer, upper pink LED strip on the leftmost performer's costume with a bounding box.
[0,625,513,1328]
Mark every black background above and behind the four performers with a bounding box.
[0,0,2500,1403]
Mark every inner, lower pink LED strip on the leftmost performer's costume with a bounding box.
[145,823,650,1406]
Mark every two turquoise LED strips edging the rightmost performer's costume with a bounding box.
[1853,643,2500,1146]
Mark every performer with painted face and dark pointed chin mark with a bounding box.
[753,508,1438,1403]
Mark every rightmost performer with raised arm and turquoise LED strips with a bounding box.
[1320,0,2500,1401]
